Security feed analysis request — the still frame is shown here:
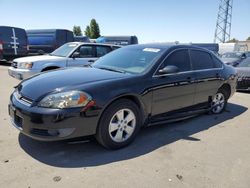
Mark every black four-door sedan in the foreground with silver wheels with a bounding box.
[9,44,237,149]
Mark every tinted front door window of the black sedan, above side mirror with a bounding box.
[161,50,191,72]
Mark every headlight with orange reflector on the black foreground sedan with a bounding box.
[38,91,92,108]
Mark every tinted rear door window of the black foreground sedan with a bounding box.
[190,50,214,70]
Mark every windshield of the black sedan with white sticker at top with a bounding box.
[93,47,164,74]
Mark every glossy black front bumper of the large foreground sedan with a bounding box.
[9,91,98,141]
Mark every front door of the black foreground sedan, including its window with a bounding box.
[152,49,195,116]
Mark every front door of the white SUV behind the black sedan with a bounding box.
[67,45,97,67]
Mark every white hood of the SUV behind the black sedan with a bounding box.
[14,55,66,63]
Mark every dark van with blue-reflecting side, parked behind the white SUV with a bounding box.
[26,29,74,55]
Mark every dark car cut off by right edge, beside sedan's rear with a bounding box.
[236,57,250,91]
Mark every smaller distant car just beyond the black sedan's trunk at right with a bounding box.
[221,52,247,67]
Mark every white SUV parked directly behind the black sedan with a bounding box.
[8,42,119,80]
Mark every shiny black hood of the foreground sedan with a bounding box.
[18,67,129,100]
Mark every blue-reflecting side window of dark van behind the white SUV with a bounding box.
[28,35,55,45]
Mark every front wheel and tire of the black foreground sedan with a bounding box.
[96,99,142,149]
